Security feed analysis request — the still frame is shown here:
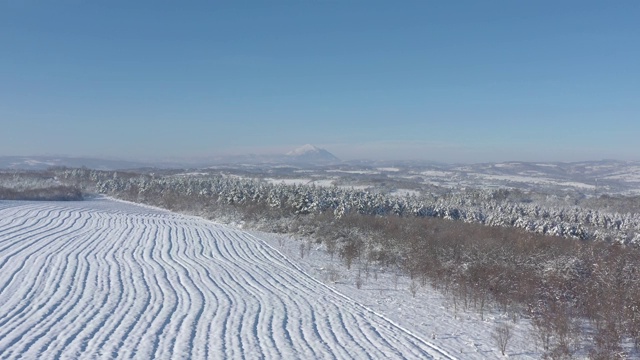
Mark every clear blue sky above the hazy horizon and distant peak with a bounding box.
[0,0,640,162]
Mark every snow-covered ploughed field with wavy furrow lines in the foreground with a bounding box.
[0,199,452,359]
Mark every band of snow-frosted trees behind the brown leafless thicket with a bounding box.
[59,169,640,245]
